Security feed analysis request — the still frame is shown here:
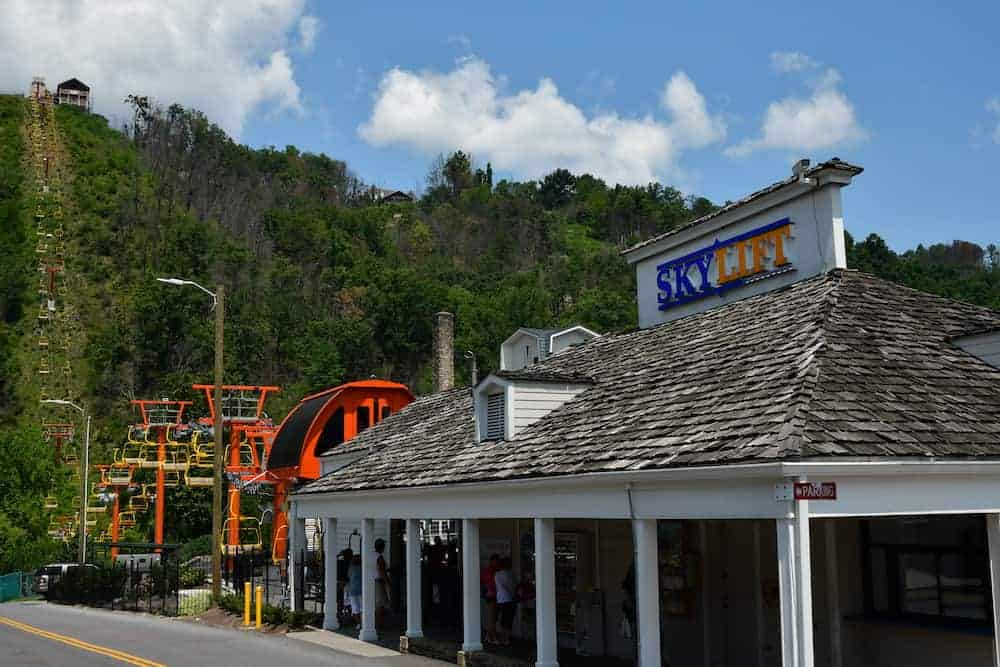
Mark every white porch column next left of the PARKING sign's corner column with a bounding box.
[632,519,662,667]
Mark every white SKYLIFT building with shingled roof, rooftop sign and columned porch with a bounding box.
[291,158,1000,667]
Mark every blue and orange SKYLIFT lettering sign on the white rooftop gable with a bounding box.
[656,218,792,310]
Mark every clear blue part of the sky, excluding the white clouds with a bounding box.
[243,2,1000,249]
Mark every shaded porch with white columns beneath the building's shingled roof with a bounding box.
[290,461,1000,667]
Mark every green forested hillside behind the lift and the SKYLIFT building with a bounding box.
[0,98,1000,571]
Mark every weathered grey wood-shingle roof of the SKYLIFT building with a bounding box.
[301,270,1000,493]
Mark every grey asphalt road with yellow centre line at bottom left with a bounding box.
[0,602,442,667]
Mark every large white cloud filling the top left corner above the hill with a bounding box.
[0,0,318,137]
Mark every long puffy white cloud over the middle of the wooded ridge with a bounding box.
[359,58,726,184]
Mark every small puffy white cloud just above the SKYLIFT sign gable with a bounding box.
[725,69,867,157]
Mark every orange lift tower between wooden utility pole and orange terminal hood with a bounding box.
[193,384,281,554]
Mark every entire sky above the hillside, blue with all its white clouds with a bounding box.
[0,0,1000,250]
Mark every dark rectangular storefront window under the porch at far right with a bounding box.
[862,516,990,622]
